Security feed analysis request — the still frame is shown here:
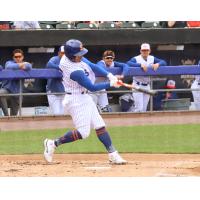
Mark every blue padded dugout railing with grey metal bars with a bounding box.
[0,65,200,116]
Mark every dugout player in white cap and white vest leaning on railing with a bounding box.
[127,43,167,112]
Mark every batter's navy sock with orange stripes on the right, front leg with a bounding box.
[96,127,116,153]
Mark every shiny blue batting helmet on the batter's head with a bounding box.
[64,39,88,57]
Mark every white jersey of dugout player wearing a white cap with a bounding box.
[133,55,154,83]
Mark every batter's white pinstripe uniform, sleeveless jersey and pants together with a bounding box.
[59,56,105,138]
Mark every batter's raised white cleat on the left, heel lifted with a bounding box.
[44,139,56,163]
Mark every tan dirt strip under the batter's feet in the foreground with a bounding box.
[0,154,200,177]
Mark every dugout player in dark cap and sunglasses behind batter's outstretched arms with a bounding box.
[95,50,129,112]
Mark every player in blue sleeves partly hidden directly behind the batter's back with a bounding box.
[46,46,65,115]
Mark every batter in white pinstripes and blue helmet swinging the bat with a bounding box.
[44,39,127,164]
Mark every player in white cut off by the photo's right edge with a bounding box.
[191,60,200,110]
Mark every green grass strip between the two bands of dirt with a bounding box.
[0,124,200,154]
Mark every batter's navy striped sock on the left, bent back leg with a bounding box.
[54,130,82,146]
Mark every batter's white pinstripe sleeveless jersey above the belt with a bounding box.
[59,55,95,94]
